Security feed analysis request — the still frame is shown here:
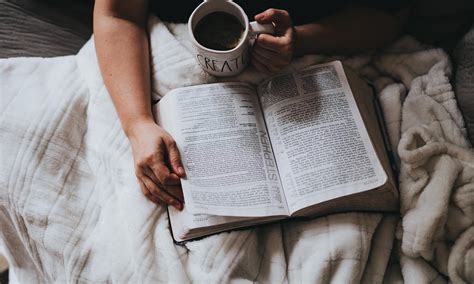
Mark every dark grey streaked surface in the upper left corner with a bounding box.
[0,0,93,58]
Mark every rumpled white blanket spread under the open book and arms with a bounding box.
[0,19,474,283]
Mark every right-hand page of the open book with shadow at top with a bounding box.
[258,61,387,212]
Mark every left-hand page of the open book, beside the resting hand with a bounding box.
[157,83,288,216]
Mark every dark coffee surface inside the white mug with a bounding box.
[194,12,244,50]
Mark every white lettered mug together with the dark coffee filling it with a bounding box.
[188,0,274,77]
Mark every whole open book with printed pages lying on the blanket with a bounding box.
[154,61,398,242]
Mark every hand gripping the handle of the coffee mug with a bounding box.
[251,9,296,74]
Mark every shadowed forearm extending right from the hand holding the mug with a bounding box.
[295,7,402,56]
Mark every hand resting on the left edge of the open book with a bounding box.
[129,118,185,210]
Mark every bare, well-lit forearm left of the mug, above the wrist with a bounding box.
[94,4,153,136]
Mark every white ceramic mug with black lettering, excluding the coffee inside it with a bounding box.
[188,0,275,77]
